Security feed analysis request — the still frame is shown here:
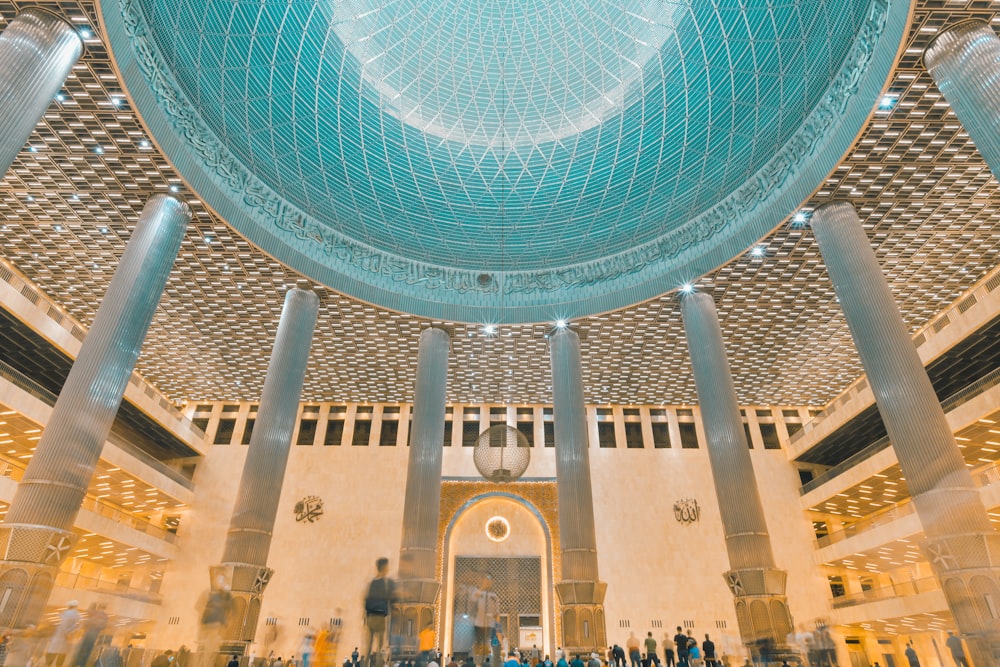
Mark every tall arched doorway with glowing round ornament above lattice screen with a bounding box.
[440,492,555,655]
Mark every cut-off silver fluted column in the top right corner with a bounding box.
[924,20,1000,183]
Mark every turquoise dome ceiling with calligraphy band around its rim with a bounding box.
[101,0,908,322]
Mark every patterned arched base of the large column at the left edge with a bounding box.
[0,525,76,629]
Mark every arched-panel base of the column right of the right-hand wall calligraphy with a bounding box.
[724,567,795,661]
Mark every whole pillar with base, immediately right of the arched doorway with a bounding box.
[549,328,608,653]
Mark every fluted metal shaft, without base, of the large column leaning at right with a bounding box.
[811,202,992,537]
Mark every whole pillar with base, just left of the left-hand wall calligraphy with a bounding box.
[208,289,319,653]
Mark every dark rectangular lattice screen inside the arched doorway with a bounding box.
[452,556,542,655]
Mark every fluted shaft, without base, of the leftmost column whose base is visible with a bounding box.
[4,195,191,531]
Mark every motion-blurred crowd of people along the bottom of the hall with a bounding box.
[0,558,968,667]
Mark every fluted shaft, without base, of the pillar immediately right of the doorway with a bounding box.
[549,329,598,581]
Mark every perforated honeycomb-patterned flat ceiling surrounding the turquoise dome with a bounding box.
[0,0,1000,405]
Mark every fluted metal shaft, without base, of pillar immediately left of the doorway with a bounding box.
[399,327,451,584]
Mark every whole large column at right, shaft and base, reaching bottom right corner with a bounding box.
[811,202,1000,665]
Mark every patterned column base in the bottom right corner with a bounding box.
[921,533,1000,665]
